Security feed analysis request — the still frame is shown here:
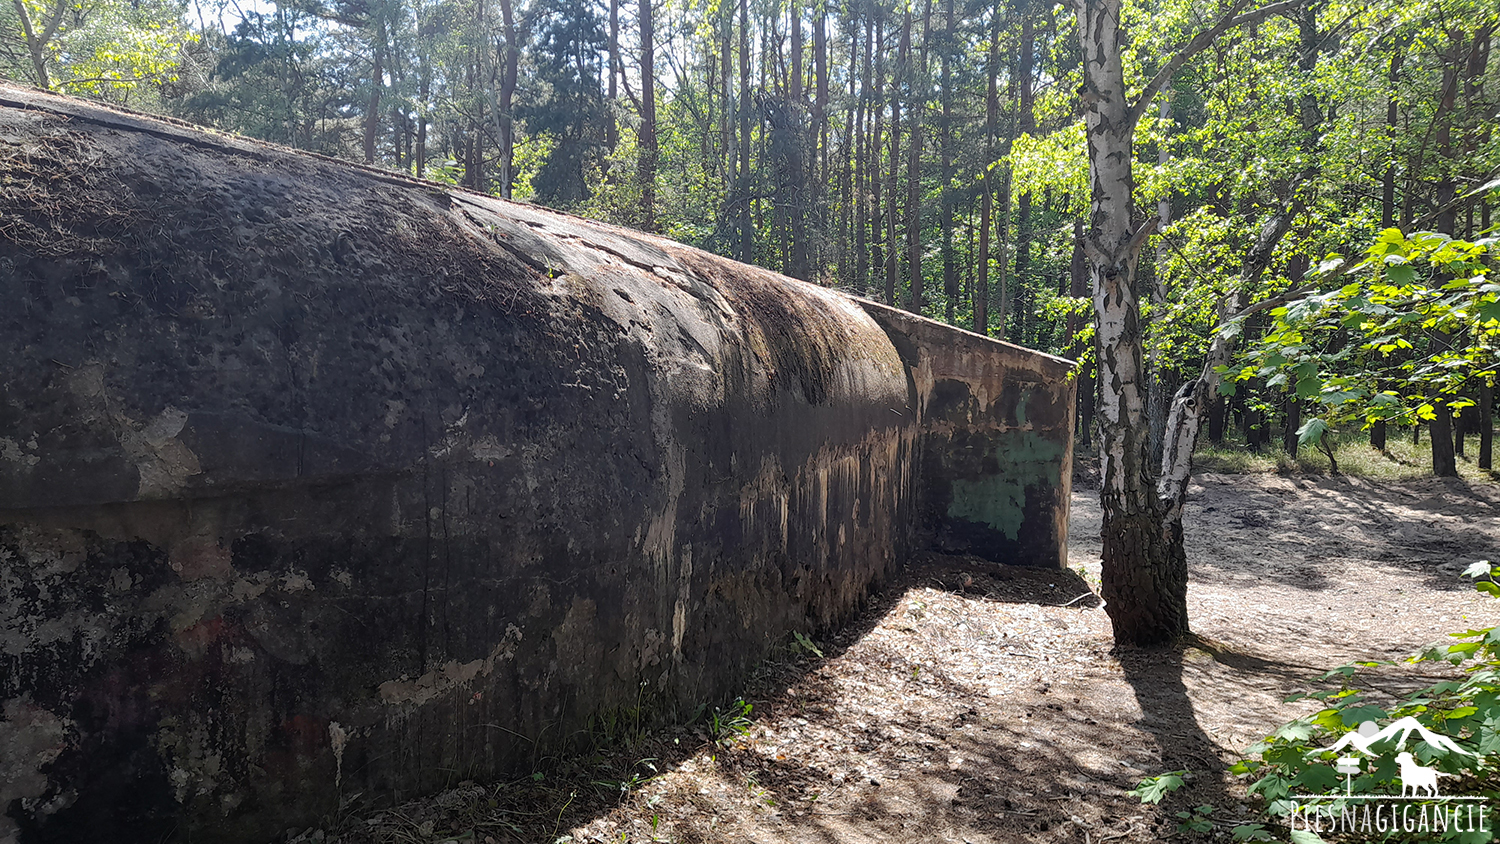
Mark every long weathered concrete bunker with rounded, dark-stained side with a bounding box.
[0,87,1071,841]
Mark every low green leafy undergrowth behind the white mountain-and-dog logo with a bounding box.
[1131,561,1500,844]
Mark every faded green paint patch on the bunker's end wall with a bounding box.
[948,430,1062,540]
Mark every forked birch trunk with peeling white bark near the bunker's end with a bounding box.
[1140,0,1326,643]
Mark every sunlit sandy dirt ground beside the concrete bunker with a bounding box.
[347,475,1500,844]
